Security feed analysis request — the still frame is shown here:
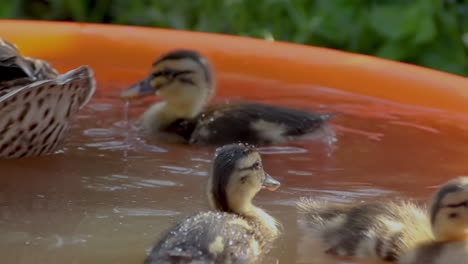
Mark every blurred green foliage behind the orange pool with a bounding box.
[0,0,468,76]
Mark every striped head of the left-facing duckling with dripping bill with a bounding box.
[120,50,214,118]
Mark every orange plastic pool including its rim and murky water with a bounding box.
[0,20,468,264]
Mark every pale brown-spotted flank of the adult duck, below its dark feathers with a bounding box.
[0,66,95,158]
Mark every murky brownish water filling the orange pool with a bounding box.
[0,68,468,264]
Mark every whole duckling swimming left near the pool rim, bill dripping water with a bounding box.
[121,50,333,146]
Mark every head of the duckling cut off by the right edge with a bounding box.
[430,176,468,241]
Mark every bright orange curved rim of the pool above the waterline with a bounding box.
[0,20,468,114]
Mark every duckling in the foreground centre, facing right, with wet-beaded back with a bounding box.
[145,144,280,264]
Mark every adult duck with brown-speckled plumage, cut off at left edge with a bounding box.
[0,36,95,158]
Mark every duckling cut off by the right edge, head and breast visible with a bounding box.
[399,176,468,264]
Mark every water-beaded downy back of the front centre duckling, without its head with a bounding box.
[145,212,276,264]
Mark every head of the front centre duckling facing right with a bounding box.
[208,144,280,214]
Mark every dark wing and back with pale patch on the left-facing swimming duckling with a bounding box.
[190,102,333,145]
